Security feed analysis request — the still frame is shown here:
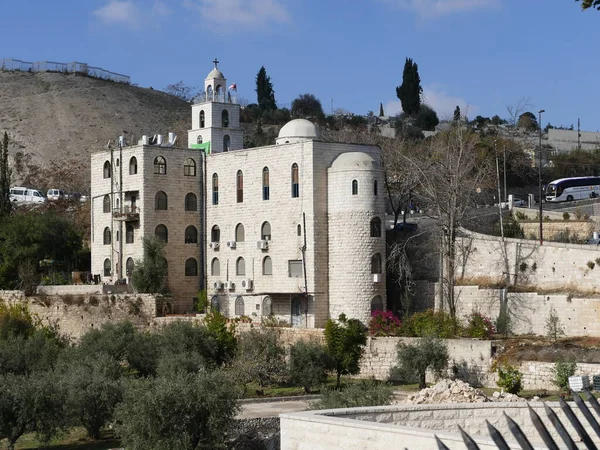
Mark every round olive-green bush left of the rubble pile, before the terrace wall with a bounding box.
[392,336,450,389]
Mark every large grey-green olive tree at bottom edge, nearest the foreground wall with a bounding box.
[115,370,238,450]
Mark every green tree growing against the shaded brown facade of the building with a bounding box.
[131,238,167,294]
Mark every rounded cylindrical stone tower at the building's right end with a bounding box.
[327,152,386,324]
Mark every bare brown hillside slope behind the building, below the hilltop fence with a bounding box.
[0,72,191,167]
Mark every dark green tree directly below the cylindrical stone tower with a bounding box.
[325,314,367,389]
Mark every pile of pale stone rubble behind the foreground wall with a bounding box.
[406,380,526,405]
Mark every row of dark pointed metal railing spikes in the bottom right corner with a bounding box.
[435,391,600,450]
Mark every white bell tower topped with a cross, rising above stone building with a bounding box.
[188,59,244,153]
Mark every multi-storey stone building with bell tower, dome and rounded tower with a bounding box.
[92,60,386,327]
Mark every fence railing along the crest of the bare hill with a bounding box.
[0,58,131,84]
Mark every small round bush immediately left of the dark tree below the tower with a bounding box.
[290,341,330,393]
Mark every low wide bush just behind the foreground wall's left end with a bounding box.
[311,380,394,409]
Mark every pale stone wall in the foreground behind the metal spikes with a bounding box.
[280,403,599,450]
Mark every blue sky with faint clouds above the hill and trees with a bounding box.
[0,0,600,131]
